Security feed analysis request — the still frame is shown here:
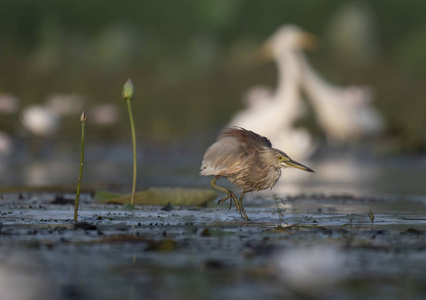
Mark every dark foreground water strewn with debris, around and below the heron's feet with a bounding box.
[0,193,426,299]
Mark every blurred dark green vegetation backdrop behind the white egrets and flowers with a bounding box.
[0,0,426,153]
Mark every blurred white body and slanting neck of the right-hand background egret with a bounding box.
[300,55,384,144]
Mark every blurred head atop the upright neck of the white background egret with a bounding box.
[258,25,317,60]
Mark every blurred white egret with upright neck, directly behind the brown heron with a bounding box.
[227,25,316,160]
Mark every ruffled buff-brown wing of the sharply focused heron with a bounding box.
[201,128,271,176]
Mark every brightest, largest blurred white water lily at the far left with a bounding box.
[21,105,59,137]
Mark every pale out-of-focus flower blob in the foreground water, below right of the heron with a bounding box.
[275,246,348,296]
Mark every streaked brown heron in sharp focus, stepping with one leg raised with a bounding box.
[200,127,313,220]
